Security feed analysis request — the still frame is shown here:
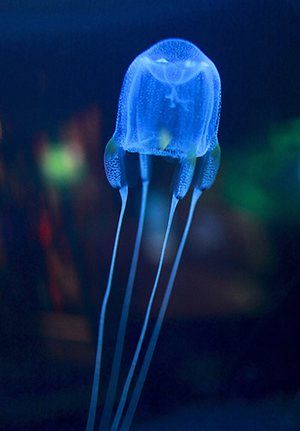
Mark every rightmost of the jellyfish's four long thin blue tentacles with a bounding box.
[121,189,201,431]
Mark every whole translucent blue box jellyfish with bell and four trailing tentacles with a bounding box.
[87,39,221,431]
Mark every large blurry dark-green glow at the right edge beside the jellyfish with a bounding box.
[223,118,300,223]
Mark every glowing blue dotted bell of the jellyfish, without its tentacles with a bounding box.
[113,39,221,158]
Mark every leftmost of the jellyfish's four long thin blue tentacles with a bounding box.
[86,186,128,431]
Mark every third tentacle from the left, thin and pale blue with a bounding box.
[111,196,178,431]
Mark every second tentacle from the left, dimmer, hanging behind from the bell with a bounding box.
[99,181,149,431]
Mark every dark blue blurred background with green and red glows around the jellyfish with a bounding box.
[0,0,300,431]
